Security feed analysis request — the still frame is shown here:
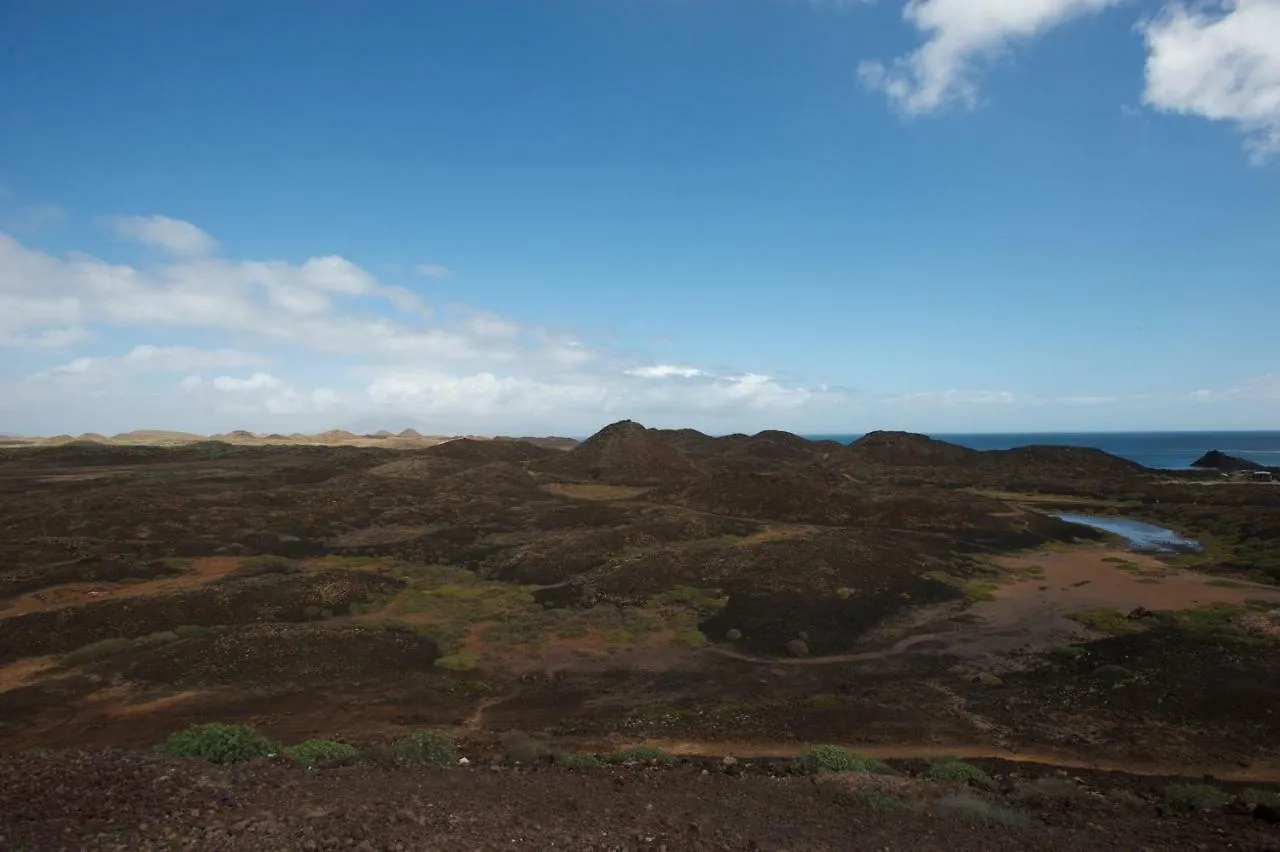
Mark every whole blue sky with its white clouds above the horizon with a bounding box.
[0,0,1280,435]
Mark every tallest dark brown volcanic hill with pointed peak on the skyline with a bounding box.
[535,420,698,485]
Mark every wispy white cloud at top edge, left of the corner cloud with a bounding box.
[858,0,1124,115]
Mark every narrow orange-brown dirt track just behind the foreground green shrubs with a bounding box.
[640,739,1280,784]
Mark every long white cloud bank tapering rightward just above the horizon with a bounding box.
[0,216,1280,435]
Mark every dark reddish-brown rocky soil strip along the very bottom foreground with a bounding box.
[0,751,1280,852]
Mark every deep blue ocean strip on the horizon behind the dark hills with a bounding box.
[805,432,1280,471]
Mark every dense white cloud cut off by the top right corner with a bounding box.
[1139,0,1280,162]
